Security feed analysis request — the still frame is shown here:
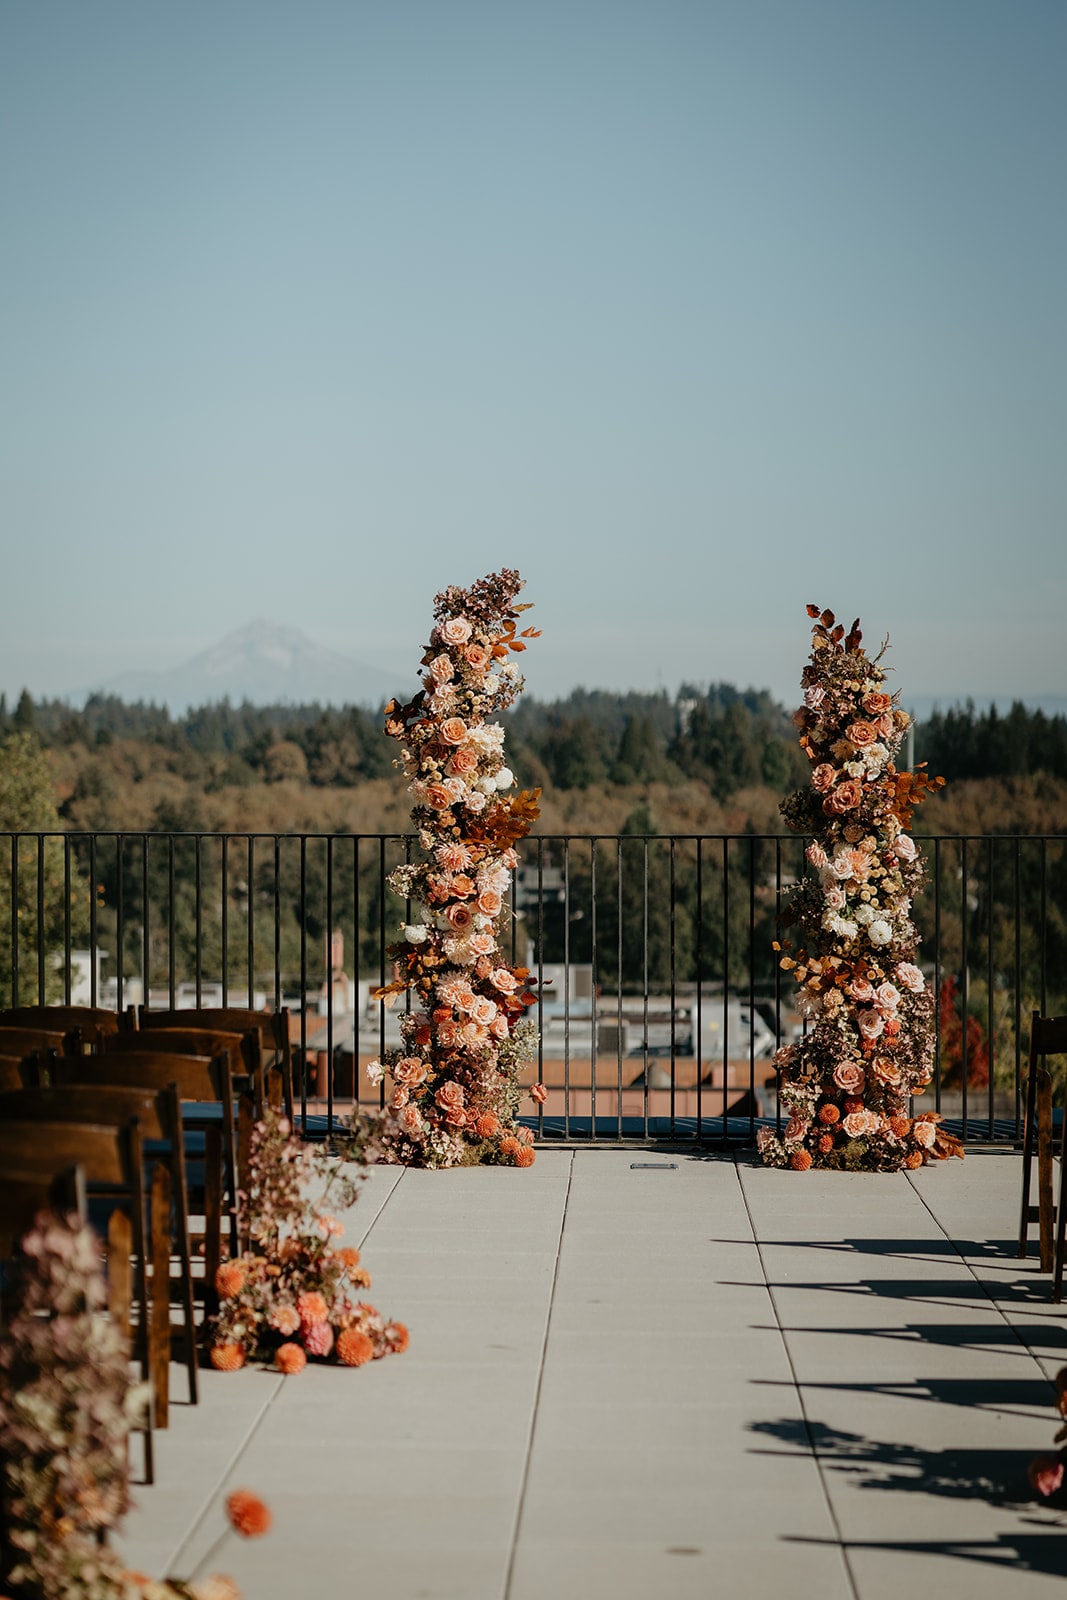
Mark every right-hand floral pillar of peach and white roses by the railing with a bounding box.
[758,606,963,1171]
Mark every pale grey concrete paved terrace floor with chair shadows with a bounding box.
[116,1149,1067,1600]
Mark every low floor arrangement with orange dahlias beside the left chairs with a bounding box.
[210,1110,408,1373]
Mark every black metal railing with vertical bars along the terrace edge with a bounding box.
[0,832,1067,1142]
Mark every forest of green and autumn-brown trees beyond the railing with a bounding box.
[0,685,1067,1048]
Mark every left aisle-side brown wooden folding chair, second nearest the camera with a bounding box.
[0,1117,155,1483]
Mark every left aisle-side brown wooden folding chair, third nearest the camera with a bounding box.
[18,1075,198,1427]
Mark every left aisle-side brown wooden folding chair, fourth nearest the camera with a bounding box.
[60,1035,241,1306]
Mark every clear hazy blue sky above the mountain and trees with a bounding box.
[0,0,1067,701]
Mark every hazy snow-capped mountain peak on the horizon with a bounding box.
[82,618,406,714]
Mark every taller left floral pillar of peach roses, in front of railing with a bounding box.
[371,568,544,1166]
